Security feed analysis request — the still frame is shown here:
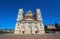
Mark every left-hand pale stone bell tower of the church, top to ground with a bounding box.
[14,8,23,34]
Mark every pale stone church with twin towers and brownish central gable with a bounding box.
[14,8,45,34]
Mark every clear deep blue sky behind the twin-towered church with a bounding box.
[0,0,60,29]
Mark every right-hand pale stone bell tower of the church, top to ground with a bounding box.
[36,8,45,34]
